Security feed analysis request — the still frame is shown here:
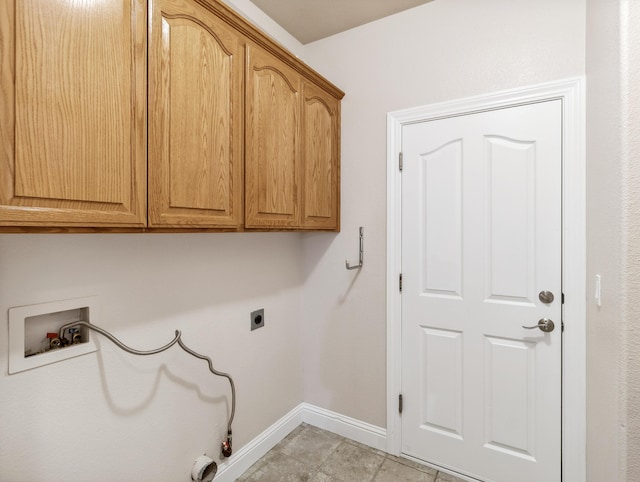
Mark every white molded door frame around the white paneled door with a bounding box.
[386,77,586,482]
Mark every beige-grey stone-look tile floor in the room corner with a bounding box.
[236,424,464,482]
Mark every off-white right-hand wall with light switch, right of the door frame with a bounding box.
[587,0,640,482]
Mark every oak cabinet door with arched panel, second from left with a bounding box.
[149,0,243,228]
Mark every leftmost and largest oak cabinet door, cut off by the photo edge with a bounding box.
[0,0,146,226]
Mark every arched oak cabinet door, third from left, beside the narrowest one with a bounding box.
[245,46,302,228]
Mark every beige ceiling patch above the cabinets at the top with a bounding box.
[252,0,432,44]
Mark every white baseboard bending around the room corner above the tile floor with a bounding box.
[214,403,387,482]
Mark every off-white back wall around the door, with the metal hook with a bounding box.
[303,0,585,427]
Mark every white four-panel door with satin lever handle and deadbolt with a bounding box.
[402,100,562,482]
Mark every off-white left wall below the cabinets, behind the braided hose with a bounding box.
[0,233,302,482]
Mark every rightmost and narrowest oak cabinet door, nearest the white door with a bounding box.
[302,83,340,230]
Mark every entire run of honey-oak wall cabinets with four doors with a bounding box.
[0,0,344,231]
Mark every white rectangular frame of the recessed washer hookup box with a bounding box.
[9,296,99,374]
